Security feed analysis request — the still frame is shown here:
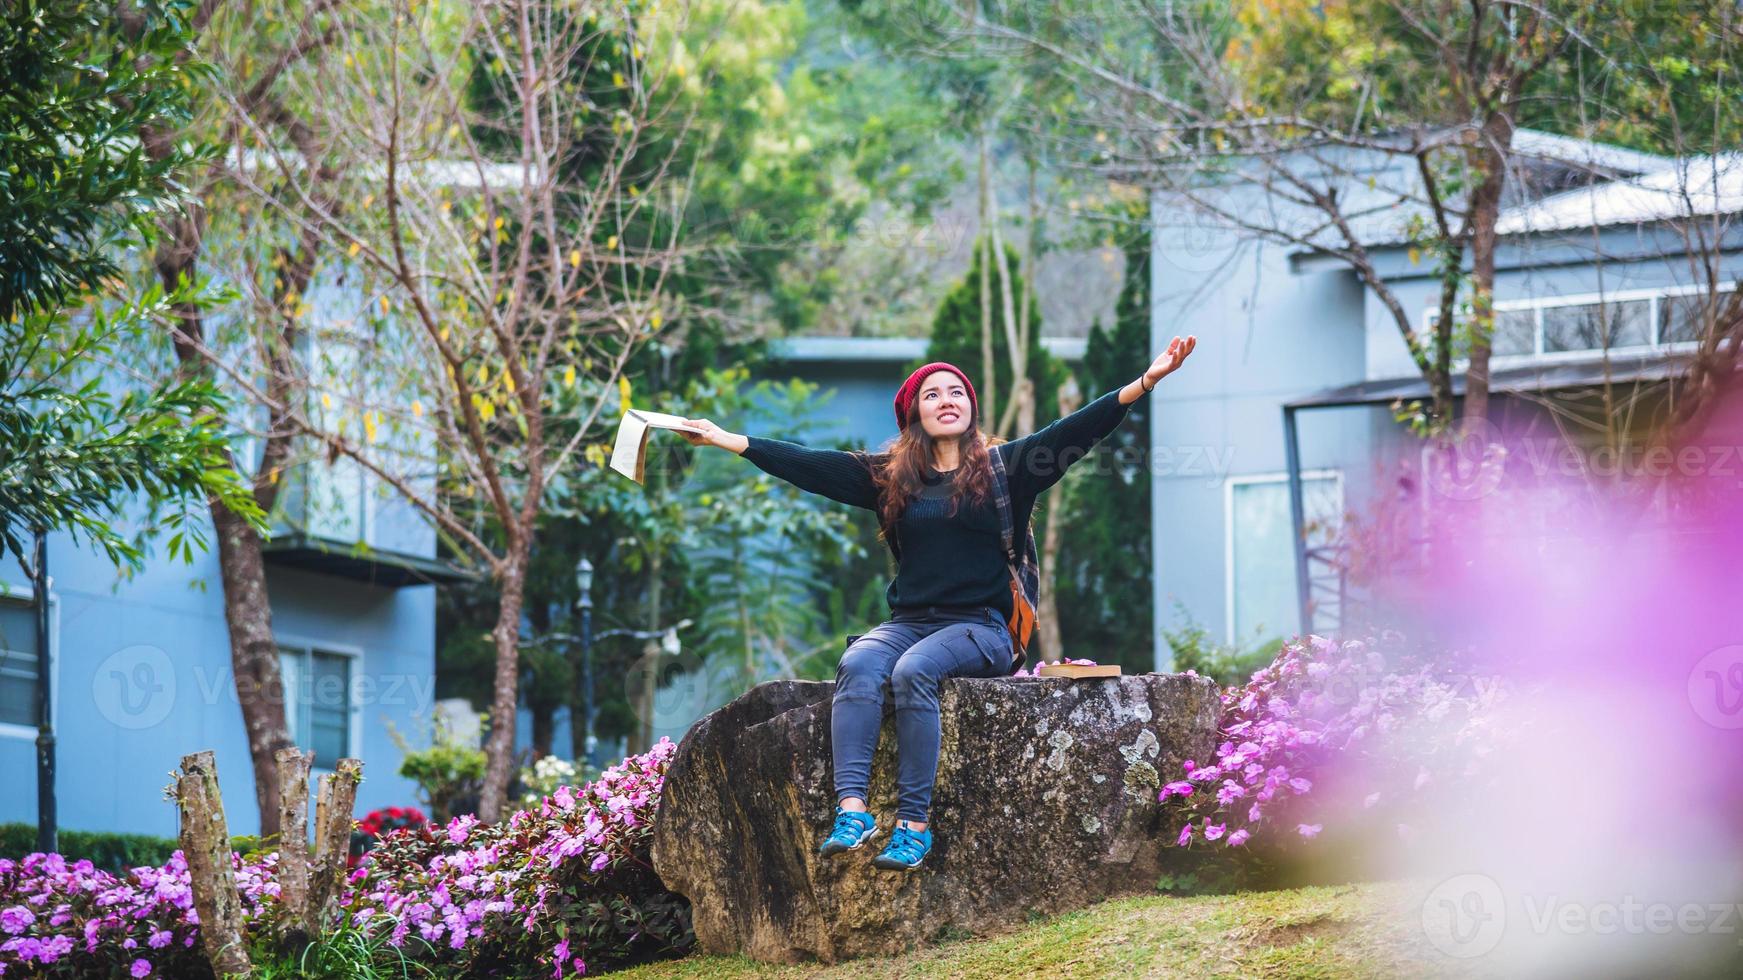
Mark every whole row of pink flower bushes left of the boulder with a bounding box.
[0,739,694,980]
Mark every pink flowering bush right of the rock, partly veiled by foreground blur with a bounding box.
[1159,633,1506,847]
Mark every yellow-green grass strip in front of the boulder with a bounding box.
[612,884,1454,980]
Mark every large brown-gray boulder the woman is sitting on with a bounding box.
[654,673,1217,963]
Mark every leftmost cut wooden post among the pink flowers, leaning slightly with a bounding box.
[176,752,253,978]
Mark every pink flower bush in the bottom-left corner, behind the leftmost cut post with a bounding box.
[0,851,279,980]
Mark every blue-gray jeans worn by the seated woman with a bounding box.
[830,605,1013,821]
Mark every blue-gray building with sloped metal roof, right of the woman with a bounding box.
[1152,131,1743,666]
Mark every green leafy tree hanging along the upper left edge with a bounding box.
[0,0,263,570]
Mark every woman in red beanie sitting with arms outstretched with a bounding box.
[683,337,1197,870]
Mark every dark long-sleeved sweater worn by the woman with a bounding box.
[743,389,1142,619]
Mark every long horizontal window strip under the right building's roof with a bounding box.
[1424,282,1736,357]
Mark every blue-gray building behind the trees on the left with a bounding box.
[0,439,451,837]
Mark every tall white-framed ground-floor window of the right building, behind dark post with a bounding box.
[1227,471,1344,645]
